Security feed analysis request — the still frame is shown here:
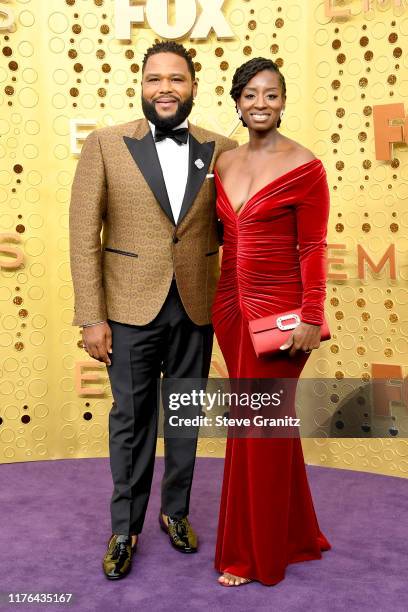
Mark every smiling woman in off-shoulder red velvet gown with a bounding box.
[213,58,330,586]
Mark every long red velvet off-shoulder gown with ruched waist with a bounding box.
[213,159,330,585]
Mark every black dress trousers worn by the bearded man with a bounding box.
[107,280,213,535]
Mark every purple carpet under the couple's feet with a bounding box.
[0,459,408,612]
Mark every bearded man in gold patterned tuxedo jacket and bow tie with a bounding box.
[70,42,237,580]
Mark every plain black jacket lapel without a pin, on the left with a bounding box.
[123,129,175,225]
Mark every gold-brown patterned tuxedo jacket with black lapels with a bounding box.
[70,119,237,325]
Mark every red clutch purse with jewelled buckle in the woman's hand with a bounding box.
[249,308,331,357]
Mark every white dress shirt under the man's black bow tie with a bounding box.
[149,119,189,223]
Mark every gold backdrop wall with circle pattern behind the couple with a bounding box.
[0,0,408,476]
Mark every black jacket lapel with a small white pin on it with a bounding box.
[177,132,215,225]
